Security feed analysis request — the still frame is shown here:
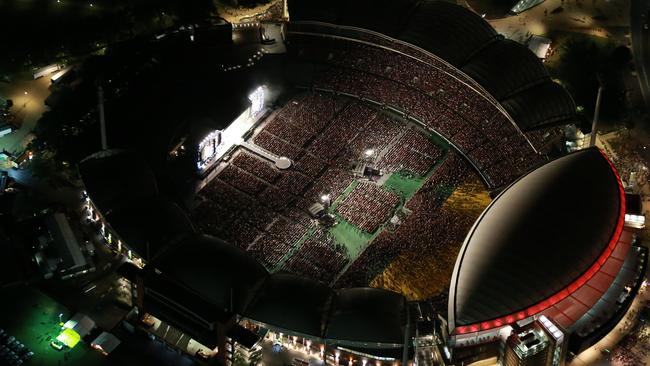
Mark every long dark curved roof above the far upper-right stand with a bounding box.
[288,0,577,131]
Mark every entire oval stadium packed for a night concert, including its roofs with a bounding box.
[74,1,647,365]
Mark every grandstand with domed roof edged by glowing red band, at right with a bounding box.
[448,148,647,362]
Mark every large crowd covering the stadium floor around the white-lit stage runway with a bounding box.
[192,93,484,285]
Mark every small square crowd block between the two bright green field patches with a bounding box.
[337,183,399,233]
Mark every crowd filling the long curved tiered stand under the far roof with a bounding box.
[290,34,540,187]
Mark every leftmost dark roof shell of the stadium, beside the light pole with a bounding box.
[79,150,158,214]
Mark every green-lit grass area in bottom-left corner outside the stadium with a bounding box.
[0,287,108,366]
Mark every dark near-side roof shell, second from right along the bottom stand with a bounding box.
[244,273,333,338]
